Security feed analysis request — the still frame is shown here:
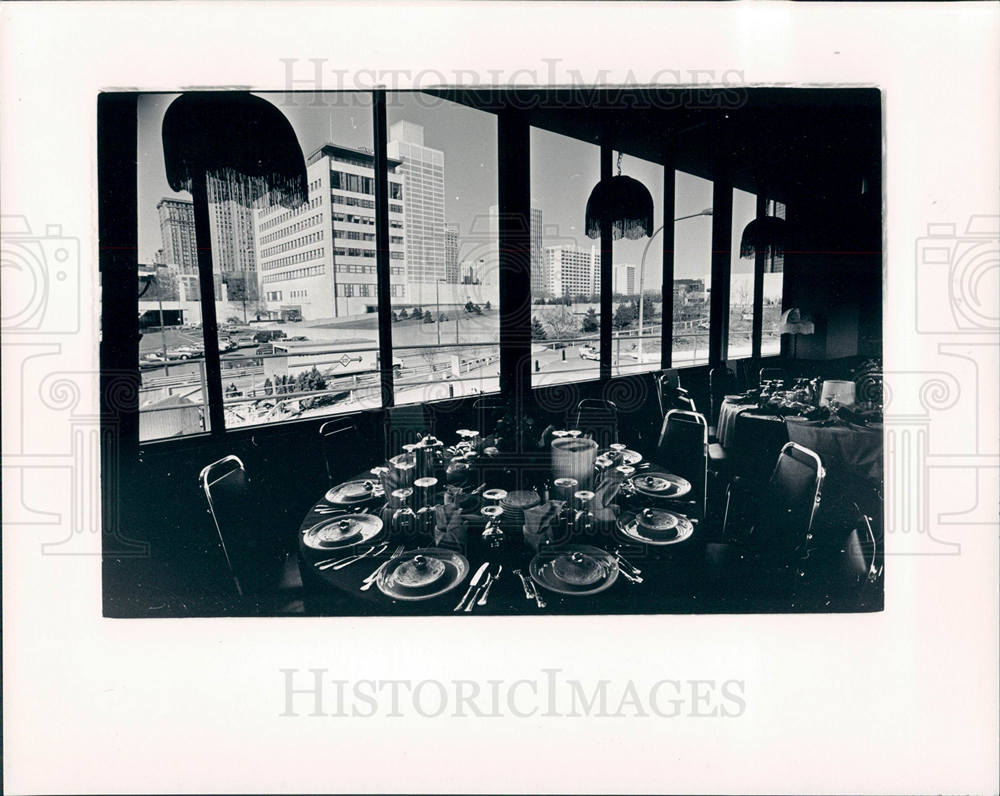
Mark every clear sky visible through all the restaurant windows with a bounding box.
[138,92,780,294]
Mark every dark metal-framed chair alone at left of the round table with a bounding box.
[198,456,301,609]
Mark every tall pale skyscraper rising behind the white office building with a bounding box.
[386,121,446,282]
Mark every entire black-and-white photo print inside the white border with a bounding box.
[97,85,884,618]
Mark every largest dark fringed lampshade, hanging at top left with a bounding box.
[163,91,308,208]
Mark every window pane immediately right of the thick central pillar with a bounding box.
[531,128,601,387]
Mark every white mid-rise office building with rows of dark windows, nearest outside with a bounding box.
[253,144,406,320]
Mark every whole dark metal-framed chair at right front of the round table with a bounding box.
[706,442,826,588]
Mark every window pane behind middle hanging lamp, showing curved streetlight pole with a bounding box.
[611,155,663,375]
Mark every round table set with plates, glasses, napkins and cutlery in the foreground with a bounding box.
[299,422,696,615]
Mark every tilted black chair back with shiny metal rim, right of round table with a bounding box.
[753,442,826,552]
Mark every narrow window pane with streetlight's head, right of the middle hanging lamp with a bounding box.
[672,171,712,367]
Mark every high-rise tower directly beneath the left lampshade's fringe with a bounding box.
[208,180,257,300]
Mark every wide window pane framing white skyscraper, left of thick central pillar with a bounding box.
[387,92,500,406]
